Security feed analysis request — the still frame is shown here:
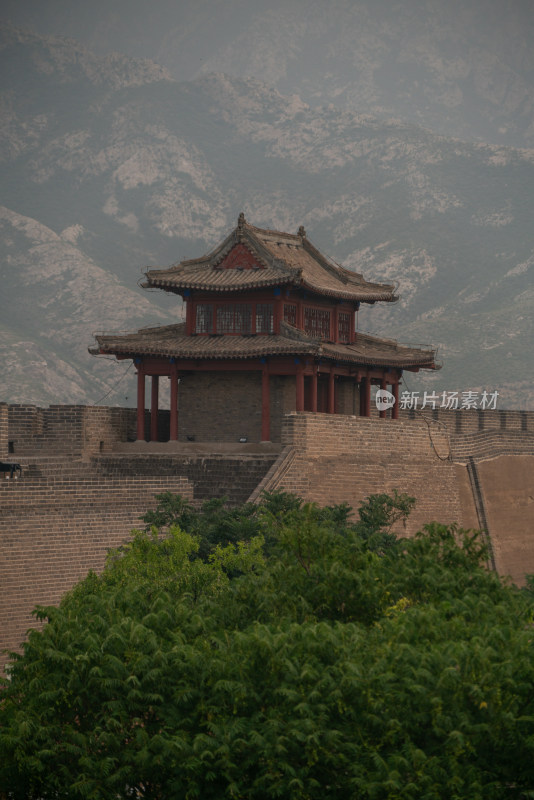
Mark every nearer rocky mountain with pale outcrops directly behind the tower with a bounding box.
[0,27,534,408]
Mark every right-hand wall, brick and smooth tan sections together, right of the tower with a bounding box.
[253,411,534,585]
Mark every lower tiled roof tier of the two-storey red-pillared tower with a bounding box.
[90,322,439,369]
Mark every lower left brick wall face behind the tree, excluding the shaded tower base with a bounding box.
[0,457,193,668]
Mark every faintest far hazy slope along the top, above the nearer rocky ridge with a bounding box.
[2,0,534,146]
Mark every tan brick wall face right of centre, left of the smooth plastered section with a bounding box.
[278,413,463,533]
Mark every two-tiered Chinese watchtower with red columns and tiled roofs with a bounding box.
[90,214,439,441]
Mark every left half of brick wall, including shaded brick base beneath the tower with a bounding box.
[0,424,276,667]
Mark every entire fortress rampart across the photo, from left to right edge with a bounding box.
[0,404,534,672]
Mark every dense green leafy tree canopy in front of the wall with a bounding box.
[0,493,534,800]
